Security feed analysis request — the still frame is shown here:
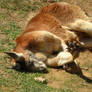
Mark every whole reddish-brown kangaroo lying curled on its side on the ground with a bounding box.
[7,3,92,71]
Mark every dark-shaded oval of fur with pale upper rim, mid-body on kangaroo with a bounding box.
[24,31,62,54]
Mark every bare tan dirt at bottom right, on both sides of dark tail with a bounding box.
[45,50,92,92]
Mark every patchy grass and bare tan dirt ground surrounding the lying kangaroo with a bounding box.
[0,0,92,92]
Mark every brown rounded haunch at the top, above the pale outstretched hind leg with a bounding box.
[41,2,89,26]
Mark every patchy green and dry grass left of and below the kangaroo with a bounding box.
[0,0,92,92]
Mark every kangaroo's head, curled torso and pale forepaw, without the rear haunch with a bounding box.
[7,13,76,71]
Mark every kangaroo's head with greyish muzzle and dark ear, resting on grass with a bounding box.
[5,52,47,72]
